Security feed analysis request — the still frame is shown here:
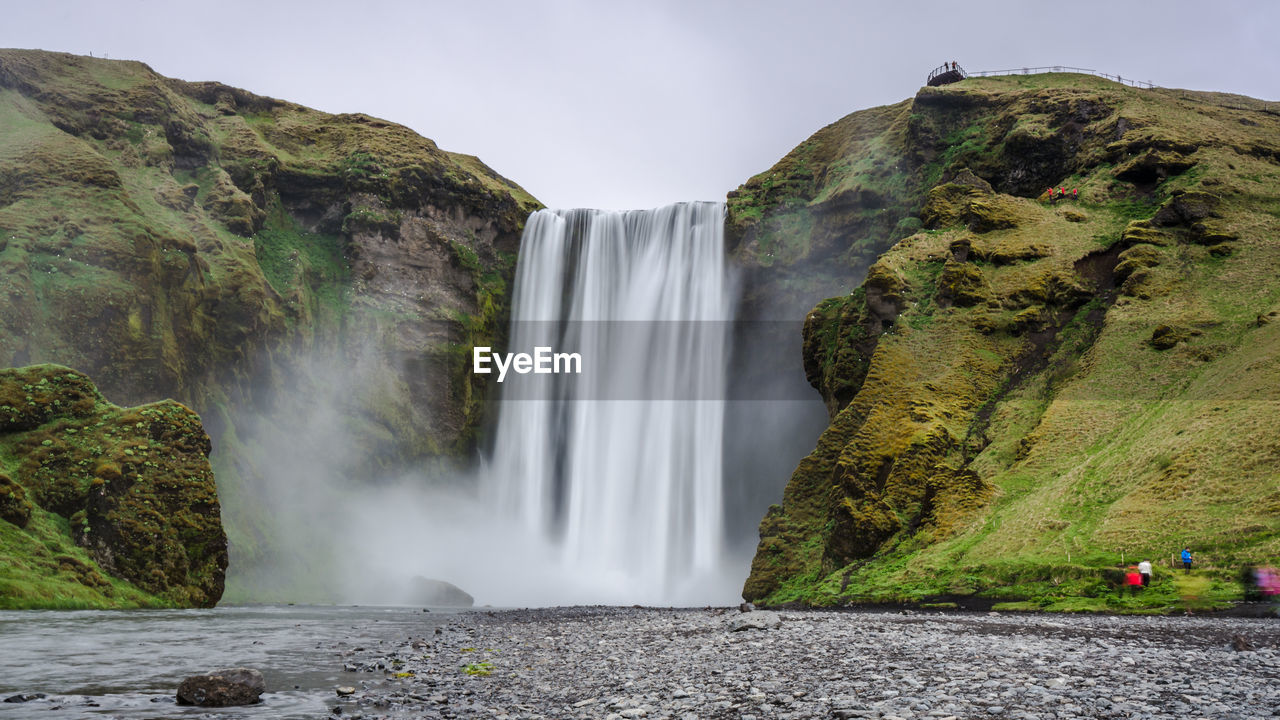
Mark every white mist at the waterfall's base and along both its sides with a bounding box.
[209,208,827,607]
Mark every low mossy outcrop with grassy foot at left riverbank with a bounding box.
[0,365,227,609]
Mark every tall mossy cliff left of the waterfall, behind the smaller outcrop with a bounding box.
[0,50,538,597]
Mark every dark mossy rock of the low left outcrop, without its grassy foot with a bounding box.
[0,365,227,607]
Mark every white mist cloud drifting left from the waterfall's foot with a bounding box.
[210,350,759,607]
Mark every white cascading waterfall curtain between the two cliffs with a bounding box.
[485,202,736,603]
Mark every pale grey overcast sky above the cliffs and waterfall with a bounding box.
[0,0,1280,209]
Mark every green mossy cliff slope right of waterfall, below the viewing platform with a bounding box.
[731,74,1280,609]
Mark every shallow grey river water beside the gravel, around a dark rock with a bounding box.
[0,606,457,720]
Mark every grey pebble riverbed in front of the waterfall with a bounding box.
[332,607,1280,720]
